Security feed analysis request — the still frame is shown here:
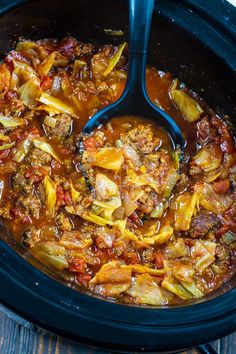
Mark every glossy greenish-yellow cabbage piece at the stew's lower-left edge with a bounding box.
[31,242,69,270]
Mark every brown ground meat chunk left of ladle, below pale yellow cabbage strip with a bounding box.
[44,113,72,140]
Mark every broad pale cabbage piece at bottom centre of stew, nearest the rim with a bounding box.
[129,274,167,305]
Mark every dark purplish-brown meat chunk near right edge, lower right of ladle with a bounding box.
[190,212,219,238]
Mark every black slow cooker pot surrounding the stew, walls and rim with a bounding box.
[0,0,236,353]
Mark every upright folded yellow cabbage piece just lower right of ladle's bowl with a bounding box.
[175,193,199,231]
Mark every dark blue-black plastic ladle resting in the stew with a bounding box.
[83,0,185,151]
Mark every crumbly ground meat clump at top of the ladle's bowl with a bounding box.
[121,125,161,154]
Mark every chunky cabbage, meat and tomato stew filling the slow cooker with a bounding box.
[0,37,236,305]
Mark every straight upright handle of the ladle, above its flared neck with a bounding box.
[124,0,154,106]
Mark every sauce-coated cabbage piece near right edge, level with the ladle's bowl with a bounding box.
[192,144,223,172]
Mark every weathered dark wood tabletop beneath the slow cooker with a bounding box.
[0,312,236,354]
